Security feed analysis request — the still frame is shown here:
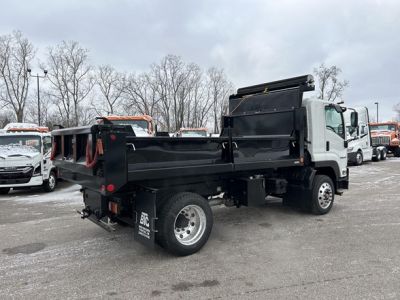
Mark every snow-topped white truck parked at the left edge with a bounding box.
[0,123,57,194]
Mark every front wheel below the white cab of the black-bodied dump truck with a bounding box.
[311,175,335,215]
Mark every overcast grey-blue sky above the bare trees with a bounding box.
[0,0,400,119]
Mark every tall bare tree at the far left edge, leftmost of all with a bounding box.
[0,31,35,122]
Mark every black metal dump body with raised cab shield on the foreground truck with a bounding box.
[52,75,314,194]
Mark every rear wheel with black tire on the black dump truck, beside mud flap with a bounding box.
[157,193,213,256]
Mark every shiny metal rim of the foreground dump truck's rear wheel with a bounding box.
[174,205,207,246]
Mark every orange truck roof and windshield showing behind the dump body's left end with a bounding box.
[97,115,155,136]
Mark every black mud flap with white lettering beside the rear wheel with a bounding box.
[134,191,157,247]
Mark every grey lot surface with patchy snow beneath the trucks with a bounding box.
[0,158,400,299]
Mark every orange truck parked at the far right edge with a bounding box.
[369,121,400,157]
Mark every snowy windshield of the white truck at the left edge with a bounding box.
[0,135,41,156]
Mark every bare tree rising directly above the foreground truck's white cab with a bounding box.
[314,64,349,101]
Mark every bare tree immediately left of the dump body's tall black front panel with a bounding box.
[207,68,233,133]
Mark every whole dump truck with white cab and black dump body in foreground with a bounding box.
[52,75,358,255]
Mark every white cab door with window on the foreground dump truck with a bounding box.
[325,104,347,177]
